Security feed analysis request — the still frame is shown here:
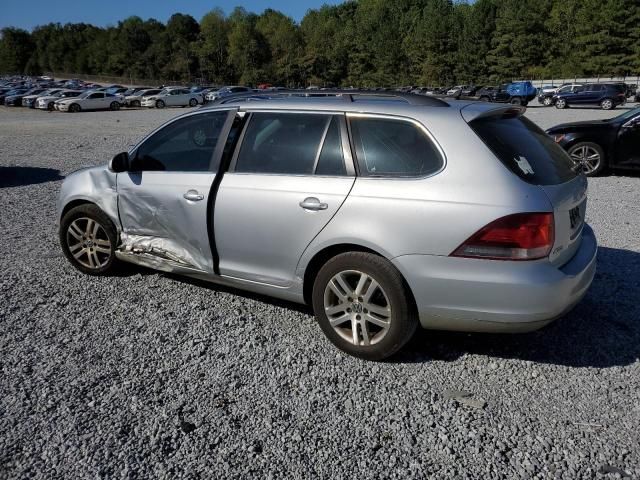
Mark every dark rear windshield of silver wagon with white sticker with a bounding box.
[469,116,577,185]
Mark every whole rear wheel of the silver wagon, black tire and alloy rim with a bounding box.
[312,252,418,361]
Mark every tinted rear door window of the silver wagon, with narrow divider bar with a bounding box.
[235,113,345,175]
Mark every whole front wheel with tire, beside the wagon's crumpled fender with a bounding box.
[59,204,118,275]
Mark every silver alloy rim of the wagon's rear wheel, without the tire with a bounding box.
[324,270,391,346]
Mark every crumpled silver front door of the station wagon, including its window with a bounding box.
[117,110,235,273]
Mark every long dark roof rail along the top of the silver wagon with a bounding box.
[212,89,449,107]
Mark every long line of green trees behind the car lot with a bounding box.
[0,0,640,87]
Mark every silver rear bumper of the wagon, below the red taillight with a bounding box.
[393,225,598,332]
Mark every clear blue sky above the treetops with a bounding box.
[0,0,341,30]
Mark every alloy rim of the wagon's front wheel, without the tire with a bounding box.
[67,217,111,269]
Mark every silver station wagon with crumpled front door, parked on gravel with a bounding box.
[58,91,597,360]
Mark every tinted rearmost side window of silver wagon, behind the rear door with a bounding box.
[349,117,444,177]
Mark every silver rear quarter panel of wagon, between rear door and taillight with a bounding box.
[298,109,551,273]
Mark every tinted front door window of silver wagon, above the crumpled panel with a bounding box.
[131,111,229,172]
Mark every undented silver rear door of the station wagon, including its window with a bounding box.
[214,111,355,287]
